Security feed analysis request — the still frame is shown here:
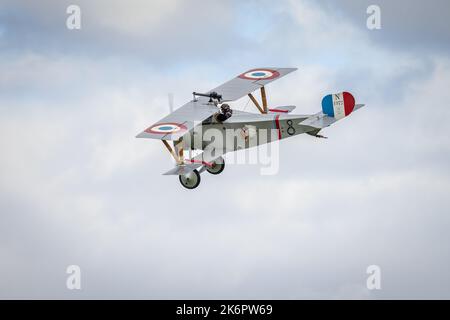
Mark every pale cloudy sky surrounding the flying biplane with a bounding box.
[0,0,450,299]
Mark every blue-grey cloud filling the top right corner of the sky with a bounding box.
[318,0,450,55]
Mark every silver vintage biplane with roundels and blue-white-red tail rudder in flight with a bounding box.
[137,68,364,189]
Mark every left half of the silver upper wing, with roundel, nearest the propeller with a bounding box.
[136,98,217,140]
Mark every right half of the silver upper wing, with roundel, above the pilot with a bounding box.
[209,68,297,101]
